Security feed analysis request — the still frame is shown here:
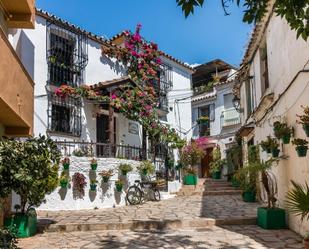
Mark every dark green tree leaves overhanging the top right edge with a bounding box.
[176,0,309,40]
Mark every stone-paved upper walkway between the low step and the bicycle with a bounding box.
[39,195,259,231]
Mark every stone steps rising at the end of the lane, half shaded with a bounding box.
[177,178,241,196]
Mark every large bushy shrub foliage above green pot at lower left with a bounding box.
[0,136,61,213]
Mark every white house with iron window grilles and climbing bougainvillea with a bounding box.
[13,10,193,209]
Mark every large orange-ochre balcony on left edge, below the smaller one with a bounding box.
[0,29,34,136]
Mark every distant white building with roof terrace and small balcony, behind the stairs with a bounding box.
[192,59,240,177]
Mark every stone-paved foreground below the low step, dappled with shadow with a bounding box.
[19,226,303,249]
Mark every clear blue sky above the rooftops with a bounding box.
[36,0,252,66]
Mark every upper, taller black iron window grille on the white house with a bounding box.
[46,20,88,86]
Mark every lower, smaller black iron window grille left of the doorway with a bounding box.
[47,93,81,136]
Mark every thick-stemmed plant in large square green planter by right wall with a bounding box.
[256,159,286,229]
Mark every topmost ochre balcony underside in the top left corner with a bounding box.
[0,0,35,29]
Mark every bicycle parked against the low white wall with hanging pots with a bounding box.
[126,180,161,205]
